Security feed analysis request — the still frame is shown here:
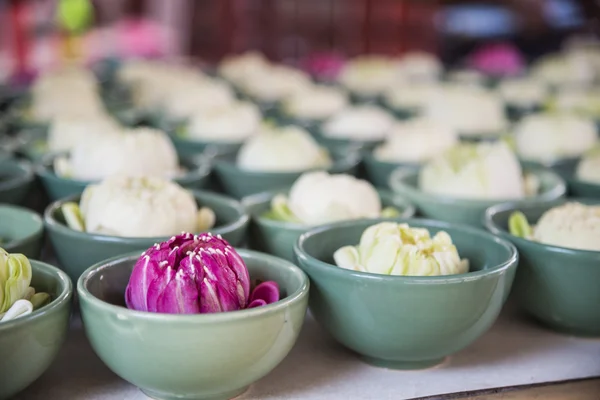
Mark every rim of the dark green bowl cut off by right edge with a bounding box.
[482,197,600,261]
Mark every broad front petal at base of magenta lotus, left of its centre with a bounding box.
[156,270,200,314]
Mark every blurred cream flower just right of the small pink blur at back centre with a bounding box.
[338,55,399,96]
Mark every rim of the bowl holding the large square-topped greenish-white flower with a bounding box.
[388,167,567,208]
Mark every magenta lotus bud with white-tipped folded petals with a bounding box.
[125,233,278,314]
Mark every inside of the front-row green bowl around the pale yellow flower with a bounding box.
[300,219,514,272]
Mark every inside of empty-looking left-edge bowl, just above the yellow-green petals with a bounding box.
[0,205,44,247]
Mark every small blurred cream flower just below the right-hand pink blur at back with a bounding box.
[498,78,550,108]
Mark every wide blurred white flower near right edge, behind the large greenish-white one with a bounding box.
[515,113,598,162]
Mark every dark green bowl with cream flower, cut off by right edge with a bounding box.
[485,198,600,337]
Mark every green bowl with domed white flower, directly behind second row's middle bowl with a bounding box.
[212,126,360,199]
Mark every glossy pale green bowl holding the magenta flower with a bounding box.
[77,250,309,400]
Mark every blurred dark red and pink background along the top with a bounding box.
[0,0,600,79]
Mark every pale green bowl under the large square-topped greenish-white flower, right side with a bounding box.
[390,168,567,227]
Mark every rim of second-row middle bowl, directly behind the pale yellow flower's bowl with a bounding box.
[241,185,417,232]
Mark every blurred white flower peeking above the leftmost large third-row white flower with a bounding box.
[48,114,121,151]
